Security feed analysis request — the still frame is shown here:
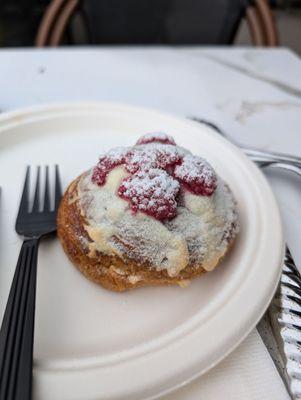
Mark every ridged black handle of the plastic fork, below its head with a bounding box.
[0,239,39,400]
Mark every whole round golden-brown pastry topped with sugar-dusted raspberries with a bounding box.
[57,133,238,291]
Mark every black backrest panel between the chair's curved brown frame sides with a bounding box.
[84,0,247,45]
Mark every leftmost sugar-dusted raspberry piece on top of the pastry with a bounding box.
[92,147,127,186]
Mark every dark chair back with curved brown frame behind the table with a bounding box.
[36,0,278,47]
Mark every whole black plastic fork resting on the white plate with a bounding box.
[0,166,61,400]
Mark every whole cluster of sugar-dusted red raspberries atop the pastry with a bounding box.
[92,133,217,220]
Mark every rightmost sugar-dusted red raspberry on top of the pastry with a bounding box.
[174,155,216,196]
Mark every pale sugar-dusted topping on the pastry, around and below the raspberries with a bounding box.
[78,167,238,276]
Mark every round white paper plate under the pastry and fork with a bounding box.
[0,103,283,400]
